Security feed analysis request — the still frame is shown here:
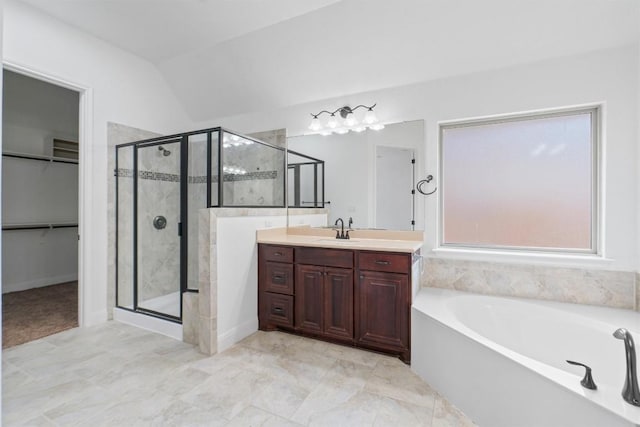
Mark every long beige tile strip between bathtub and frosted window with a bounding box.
[422,258,639,310]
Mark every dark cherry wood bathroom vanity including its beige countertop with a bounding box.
[258,228,422,363]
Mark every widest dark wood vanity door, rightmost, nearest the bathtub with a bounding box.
[356,271,409,352]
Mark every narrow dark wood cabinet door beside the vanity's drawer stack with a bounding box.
[295,264,324,334]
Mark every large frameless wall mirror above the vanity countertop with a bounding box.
[287,120,424,230]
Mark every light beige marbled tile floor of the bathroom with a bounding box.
[2,322,474,427]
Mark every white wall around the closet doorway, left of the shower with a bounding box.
[3,0,193,325]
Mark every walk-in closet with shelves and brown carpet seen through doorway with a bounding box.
[2,69,79,348]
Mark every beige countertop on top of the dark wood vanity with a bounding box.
[257,226,423,253]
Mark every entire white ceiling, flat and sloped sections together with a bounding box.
[22,0,640,122]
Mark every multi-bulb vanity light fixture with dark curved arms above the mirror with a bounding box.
[309,104,384,135]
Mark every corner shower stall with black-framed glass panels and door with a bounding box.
[115,128,286,323]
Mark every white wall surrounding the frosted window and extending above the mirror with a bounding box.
[197,45,640,270]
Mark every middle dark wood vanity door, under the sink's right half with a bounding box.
[324,267,353,342]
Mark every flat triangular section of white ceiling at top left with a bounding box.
[23,0,338,62]
